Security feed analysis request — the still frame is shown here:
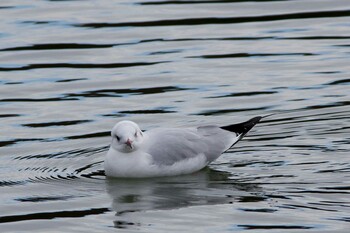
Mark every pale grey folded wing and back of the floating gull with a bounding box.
[147,126,236,165]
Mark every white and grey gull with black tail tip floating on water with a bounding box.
[104,116,264,178]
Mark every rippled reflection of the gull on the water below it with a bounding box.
[106,168,258,215]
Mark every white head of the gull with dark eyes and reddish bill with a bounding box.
[111,121,143,153]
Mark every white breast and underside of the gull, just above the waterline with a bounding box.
[104,148,208,178]
